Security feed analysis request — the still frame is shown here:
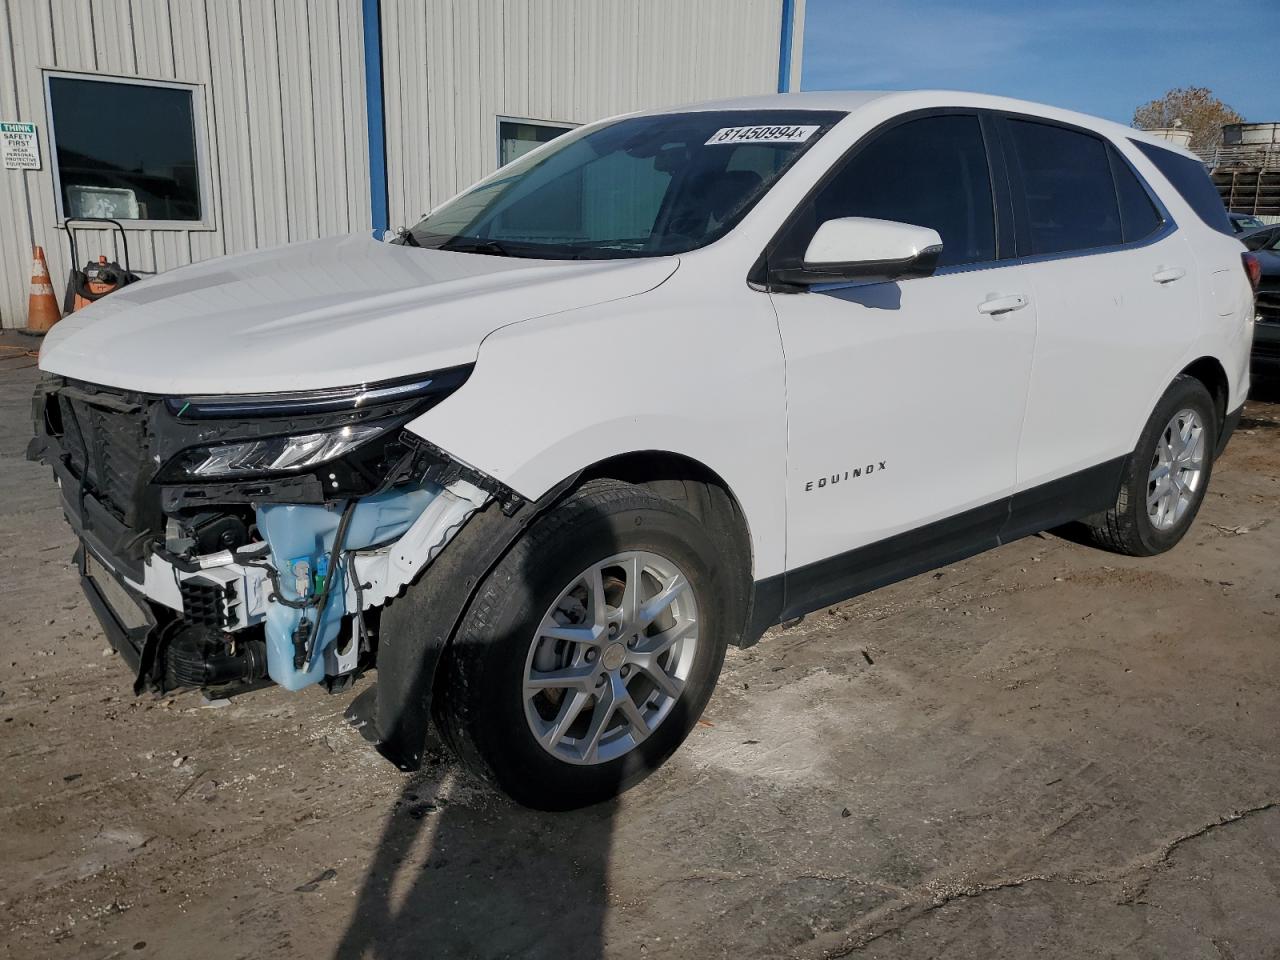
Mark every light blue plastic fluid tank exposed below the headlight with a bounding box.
[257,484,440,690]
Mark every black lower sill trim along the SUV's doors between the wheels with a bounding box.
[742,455,1126,646]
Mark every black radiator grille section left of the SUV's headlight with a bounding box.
[54,389,155,529]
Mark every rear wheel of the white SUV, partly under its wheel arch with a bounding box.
[1087,376,1217,557]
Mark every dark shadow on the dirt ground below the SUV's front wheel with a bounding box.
[333,496,617,960]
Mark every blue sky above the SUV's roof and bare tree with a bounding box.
[801,0,1280,123]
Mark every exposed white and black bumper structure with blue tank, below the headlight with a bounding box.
[67,480,489,692]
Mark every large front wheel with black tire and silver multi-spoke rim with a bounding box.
[435,480,740,810]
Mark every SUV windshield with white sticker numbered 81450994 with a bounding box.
[401,110,845,260]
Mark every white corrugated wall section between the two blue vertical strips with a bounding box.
[383,0,783,225]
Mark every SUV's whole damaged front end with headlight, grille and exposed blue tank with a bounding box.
[28,366,506,692]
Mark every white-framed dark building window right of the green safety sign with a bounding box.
[45,73,209,225]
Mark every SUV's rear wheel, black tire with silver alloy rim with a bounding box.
[1085,376,1219,557]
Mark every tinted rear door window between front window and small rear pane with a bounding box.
[1009,120,1124,255]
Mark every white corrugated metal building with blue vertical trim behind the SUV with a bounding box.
[0,0,804,326]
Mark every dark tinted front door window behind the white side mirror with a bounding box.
[797,114,996,266]
